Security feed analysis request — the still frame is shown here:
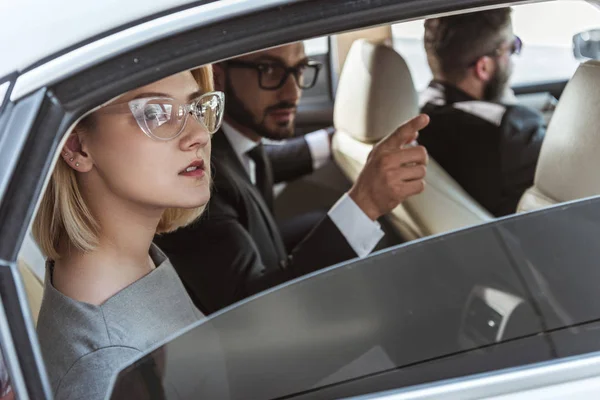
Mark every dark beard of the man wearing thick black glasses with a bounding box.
[225,79,296,140]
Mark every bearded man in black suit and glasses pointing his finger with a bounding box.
[156,43,429,314]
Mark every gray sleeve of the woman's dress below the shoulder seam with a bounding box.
[49,346,142,400]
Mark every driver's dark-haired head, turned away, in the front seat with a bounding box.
[425,8,521,101]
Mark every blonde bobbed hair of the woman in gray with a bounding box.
[32,66,214,260]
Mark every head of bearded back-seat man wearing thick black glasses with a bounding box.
[214,42,318,140]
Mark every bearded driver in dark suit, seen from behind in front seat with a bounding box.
[418,8,546,216]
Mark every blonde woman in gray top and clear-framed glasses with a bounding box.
[34,67,224,399]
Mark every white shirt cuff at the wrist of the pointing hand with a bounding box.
[327,193,384,257]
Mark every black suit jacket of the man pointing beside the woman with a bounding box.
[155,132,356,314]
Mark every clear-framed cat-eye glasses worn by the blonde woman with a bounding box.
[97,92,225,140]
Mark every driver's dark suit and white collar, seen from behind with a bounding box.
[418,81,546,216]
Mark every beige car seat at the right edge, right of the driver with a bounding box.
[518,61,600,212]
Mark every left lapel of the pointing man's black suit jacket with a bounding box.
[211,130,287,259]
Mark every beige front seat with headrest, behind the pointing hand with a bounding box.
[332,39,493,240]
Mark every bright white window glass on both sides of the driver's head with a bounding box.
[392,1,600,91]
